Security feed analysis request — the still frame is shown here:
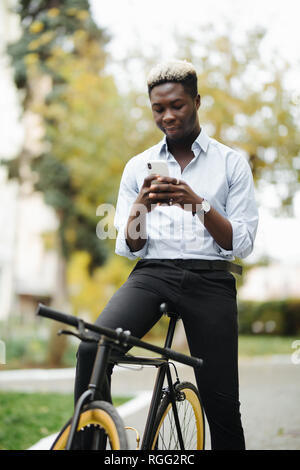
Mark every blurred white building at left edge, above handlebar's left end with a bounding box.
[0,169,57,320]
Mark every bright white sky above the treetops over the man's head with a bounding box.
[90,0,300,91]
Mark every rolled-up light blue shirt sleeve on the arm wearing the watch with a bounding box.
[219,156,258,258]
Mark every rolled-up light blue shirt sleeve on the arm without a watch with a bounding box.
[114,161,148,259]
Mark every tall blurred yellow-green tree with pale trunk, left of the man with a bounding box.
[3,0,134,365]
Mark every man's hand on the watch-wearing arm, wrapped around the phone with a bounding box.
[148,176,203,212]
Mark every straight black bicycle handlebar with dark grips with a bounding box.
[36,304,203,368]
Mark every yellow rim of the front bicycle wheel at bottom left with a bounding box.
[53,409,120,450]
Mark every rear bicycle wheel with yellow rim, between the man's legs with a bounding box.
[150,382,205,450]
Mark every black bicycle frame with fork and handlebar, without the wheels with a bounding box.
[37,304,203,450]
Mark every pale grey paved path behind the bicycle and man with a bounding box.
[0,356,300,450]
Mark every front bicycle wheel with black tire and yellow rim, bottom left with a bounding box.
[50,401,128,450]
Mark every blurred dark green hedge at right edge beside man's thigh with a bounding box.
[239,299,300,336]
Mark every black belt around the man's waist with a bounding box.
[160,259,243,275]
